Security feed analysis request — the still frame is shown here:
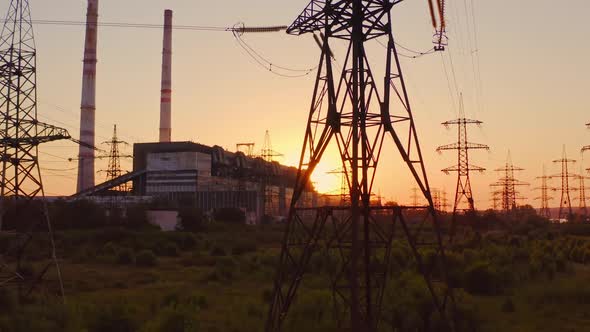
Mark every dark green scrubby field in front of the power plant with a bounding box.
[0,218,590,332]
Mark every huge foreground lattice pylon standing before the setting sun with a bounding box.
[266,0,454,332]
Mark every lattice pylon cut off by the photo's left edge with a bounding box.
[0,0,70,298]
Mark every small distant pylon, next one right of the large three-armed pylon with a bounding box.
[491,152,529,213]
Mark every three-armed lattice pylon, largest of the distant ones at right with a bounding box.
[436,95,490,214]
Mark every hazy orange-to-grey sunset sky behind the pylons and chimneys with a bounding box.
[5,0,590,209]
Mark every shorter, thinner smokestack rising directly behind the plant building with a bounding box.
[160,9,172,142]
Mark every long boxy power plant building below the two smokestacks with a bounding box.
[74,142,319,220]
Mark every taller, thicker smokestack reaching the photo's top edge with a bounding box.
[77,0,98,192]
